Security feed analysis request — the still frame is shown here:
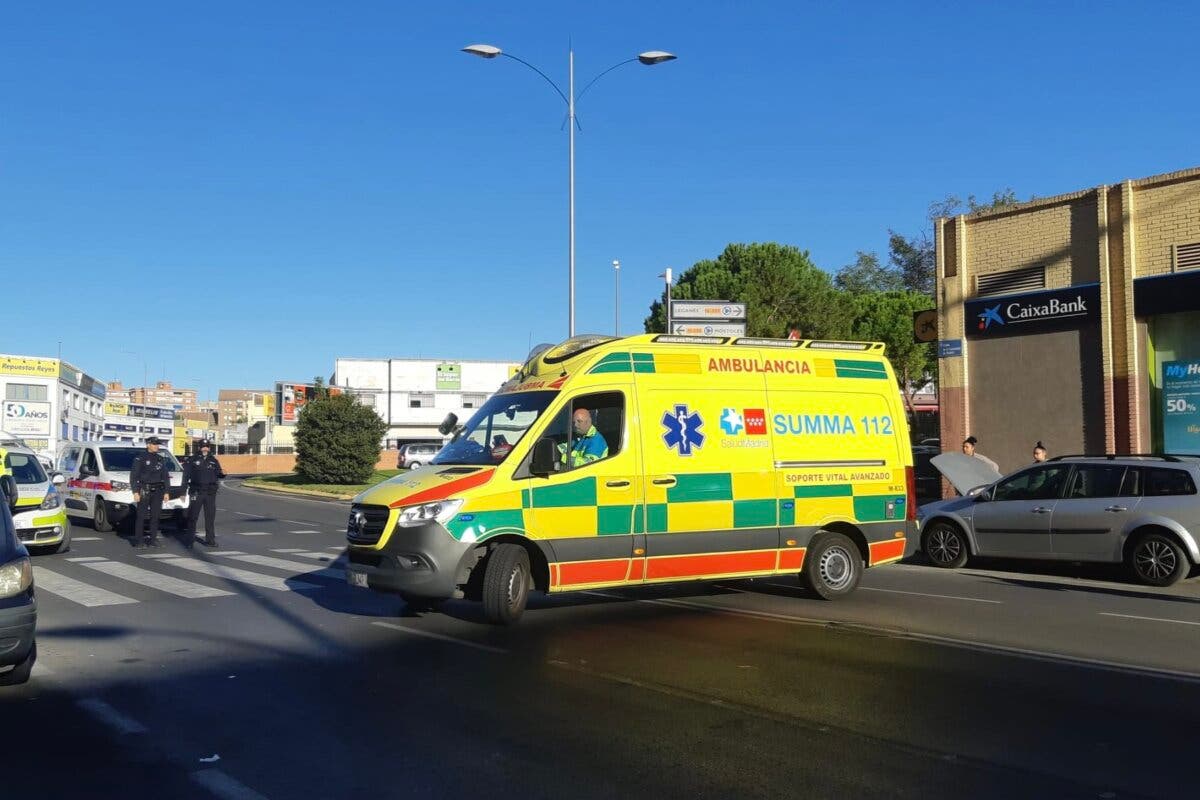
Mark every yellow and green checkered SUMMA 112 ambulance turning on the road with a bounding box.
[347,335,916,624]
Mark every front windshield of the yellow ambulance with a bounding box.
[431,391,558,465]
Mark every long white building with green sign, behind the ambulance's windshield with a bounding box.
[330,359,521,447]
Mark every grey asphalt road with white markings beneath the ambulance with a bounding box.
[7,481,1200,800]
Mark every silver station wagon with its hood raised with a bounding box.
[918,453,1200,587]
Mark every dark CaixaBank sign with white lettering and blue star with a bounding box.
[965,283,1100,338]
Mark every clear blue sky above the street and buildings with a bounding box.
[0,0,1200,396]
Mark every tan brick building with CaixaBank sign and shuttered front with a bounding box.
[935,169,1200,470]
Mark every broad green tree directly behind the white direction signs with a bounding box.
[644,242,851,338]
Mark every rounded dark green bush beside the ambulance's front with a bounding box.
[295,393,388,485]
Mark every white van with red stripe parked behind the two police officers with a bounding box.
[59,441,187,531]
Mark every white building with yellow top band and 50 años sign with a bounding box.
[0,354,106,459]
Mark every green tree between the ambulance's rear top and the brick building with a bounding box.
[852,291,937,414]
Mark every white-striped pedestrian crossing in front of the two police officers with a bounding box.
[34,546,346,608]
